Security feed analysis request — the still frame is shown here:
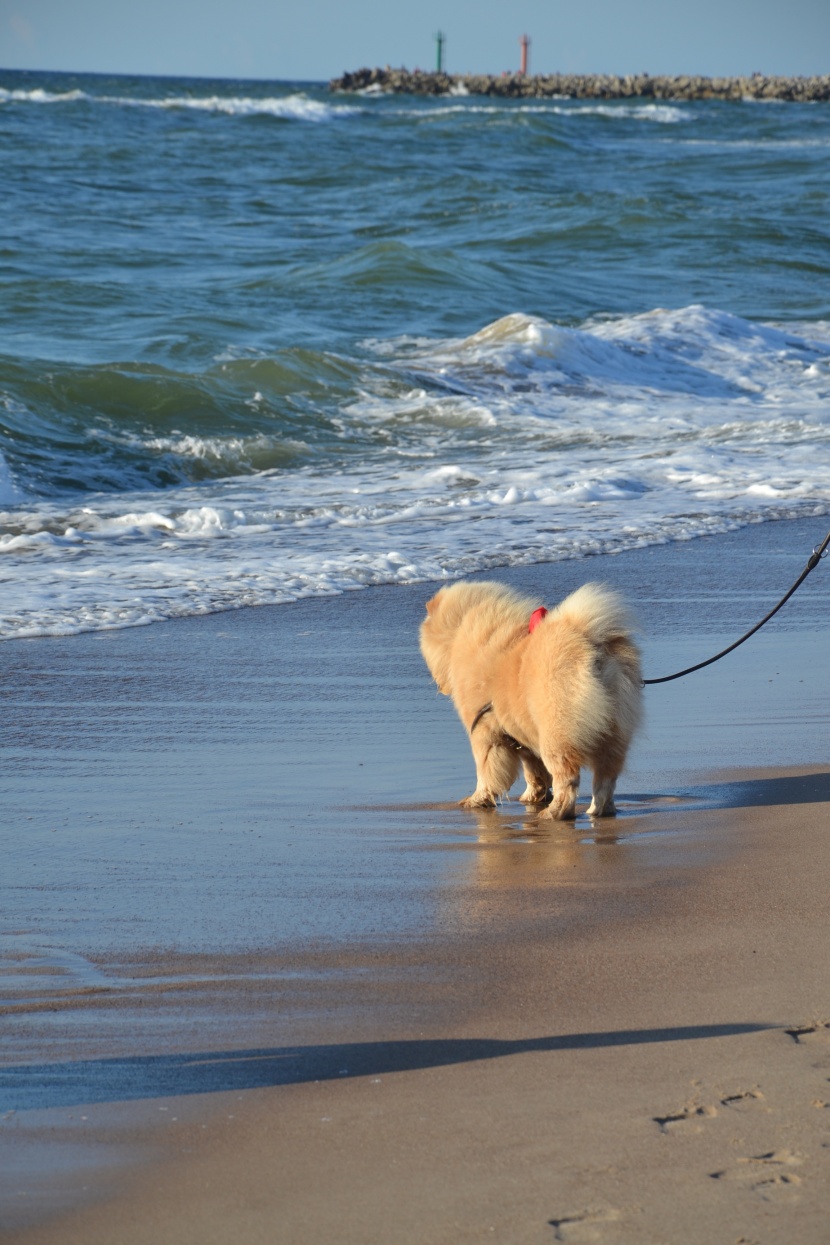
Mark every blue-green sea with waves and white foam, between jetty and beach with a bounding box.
[0,71,830,637]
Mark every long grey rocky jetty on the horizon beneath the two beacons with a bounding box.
[329,65,830,102]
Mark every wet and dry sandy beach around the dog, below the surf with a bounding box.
[0,519,830,1245]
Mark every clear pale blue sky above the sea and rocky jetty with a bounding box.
[0,0,830,80]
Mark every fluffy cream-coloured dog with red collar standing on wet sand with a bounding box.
[421,583,642,819]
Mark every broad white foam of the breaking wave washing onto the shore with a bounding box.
[0,306,830,636]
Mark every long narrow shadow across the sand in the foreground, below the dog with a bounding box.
[0,1023,775,1112]
